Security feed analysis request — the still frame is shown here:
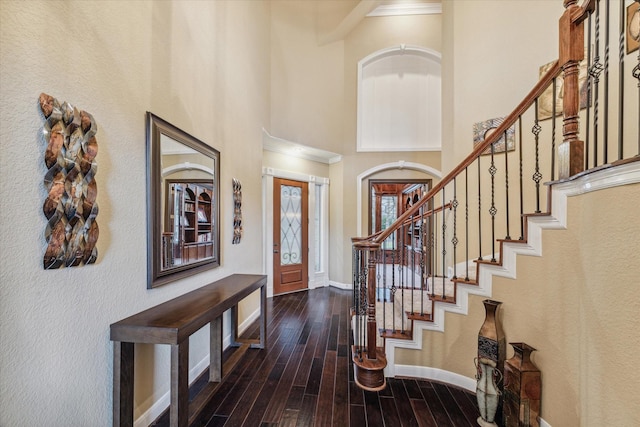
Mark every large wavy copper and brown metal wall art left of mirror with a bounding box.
[39,93,98,269]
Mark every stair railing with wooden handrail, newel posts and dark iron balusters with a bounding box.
[352,0,640,390]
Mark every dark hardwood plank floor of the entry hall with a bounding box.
[152,288,479,427]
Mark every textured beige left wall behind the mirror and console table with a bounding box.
[0,0,270,427]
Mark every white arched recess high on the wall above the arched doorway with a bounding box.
[357,45,441,151]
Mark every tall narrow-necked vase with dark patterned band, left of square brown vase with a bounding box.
[476,299,507,427]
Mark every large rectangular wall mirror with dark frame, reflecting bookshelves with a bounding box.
[147,112,220,288]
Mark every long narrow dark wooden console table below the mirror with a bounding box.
[111,274,267,427]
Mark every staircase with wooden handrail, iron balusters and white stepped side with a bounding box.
[352,0,640,390]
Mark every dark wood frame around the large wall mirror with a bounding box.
[146,112,220,289]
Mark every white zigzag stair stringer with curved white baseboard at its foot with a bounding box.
[385,161,640,384]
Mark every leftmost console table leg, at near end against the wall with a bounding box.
[113,341,134,427]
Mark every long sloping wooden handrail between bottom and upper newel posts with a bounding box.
[364,61,562,247]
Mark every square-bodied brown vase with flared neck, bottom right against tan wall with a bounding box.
[504,342,542,427]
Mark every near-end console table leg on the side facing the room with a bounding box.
[169,339,189,427]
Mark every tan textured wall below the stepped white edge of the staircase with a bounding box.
[396,184,640,427]
